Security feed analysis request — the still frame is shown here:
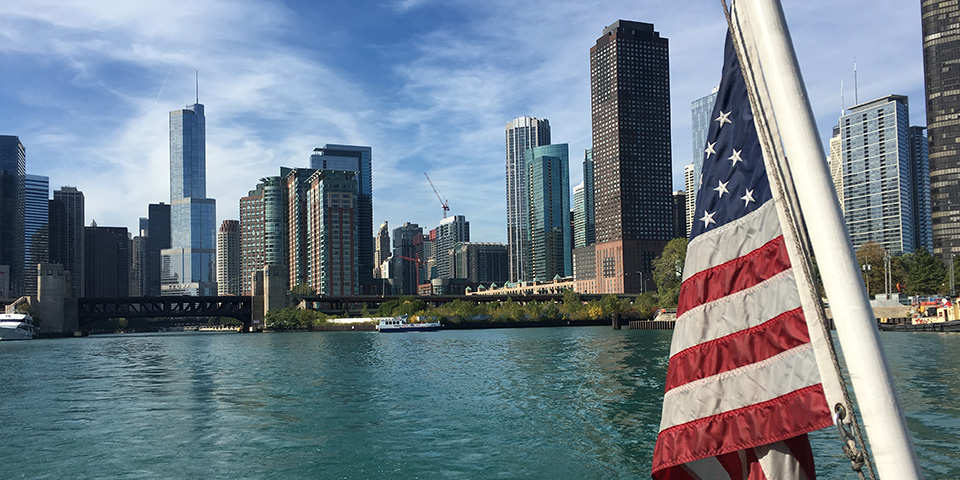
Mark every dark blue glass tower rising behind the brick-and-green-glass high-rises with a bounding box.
[310,144,381,294]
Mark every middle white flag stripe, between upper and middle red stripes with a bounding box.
[670,270,800,356]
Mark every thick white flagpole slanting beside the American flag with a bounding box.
[733,0,922,479]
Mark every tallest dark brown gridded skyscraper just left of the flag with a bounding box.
[590,20,673,293]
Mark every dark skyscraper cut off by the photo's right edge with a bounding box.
[920,0,960,259]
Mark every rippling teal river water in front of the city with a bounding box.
[0,327,960,479]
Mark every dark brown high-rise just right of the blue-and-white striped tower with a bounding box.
[50,187,86,298]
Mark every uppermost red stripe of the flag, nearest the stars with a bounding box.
[677,235,790,317]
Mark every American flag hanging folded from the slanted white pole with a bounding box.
[653,36,832,480]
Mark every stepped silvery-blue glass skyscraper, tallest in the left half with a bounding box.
[161,102,217,295]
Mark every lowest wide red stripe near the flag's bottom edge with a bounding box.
[653,383,833,479]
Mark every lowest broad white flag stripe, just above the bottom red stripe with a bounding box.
[660,343,820,430]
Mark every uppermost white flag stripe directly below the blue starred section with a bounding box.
[683,201,781,281]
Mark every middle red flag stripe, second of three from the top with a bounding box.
[666,308,810,391]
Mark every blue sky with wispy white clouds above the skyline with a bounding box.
[0,0,926,242]
